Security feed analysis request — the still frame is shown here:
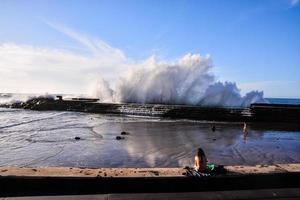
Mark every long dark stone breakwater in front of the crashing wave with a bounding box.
[1,97,300,123]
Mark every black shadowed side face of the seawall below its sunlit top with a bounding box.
[0,173,300,197]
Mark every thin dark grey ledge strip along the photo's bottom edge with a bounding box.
[0,188,300,200]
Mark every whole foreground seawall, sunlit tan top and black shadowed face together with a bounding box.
[0,164,300,196]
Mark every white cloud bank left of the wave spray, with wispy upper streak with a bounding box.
[0,24,129,93]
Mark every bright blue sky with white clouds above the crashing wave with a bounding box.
[0,0,300,98]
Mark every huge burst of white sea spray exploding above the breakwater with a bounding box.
[92,54,265,107]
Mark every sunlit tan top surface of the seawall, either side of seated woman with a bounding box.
[0,163,300,177]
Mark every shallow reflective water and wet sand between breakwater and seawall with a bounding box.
[0,108,300,167]
